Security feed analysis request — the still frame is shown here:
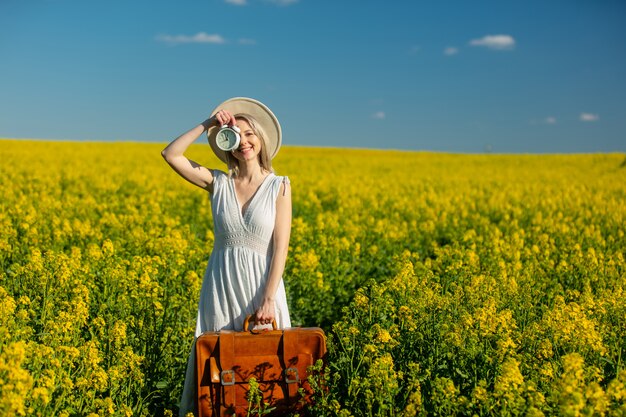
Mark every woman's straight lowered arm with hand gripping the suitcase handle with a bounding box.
[256,182,291,324]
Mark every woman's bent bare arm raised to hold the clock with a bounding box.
[161,118,217,191]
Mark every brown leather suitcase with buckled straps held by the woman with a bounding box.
[196,317,326,417]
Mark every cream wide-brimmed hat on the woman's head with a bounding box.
[207,97,283,163]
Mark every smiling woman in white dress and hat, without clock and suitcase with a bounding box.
[161,97,291,416]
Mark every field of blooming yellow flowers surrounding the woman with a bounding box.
[0,140,626,417]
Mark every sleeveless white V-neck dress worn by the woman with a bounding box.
[180,170,291,416]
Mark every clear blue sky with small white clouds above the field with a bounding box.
[0,0,626,153]
